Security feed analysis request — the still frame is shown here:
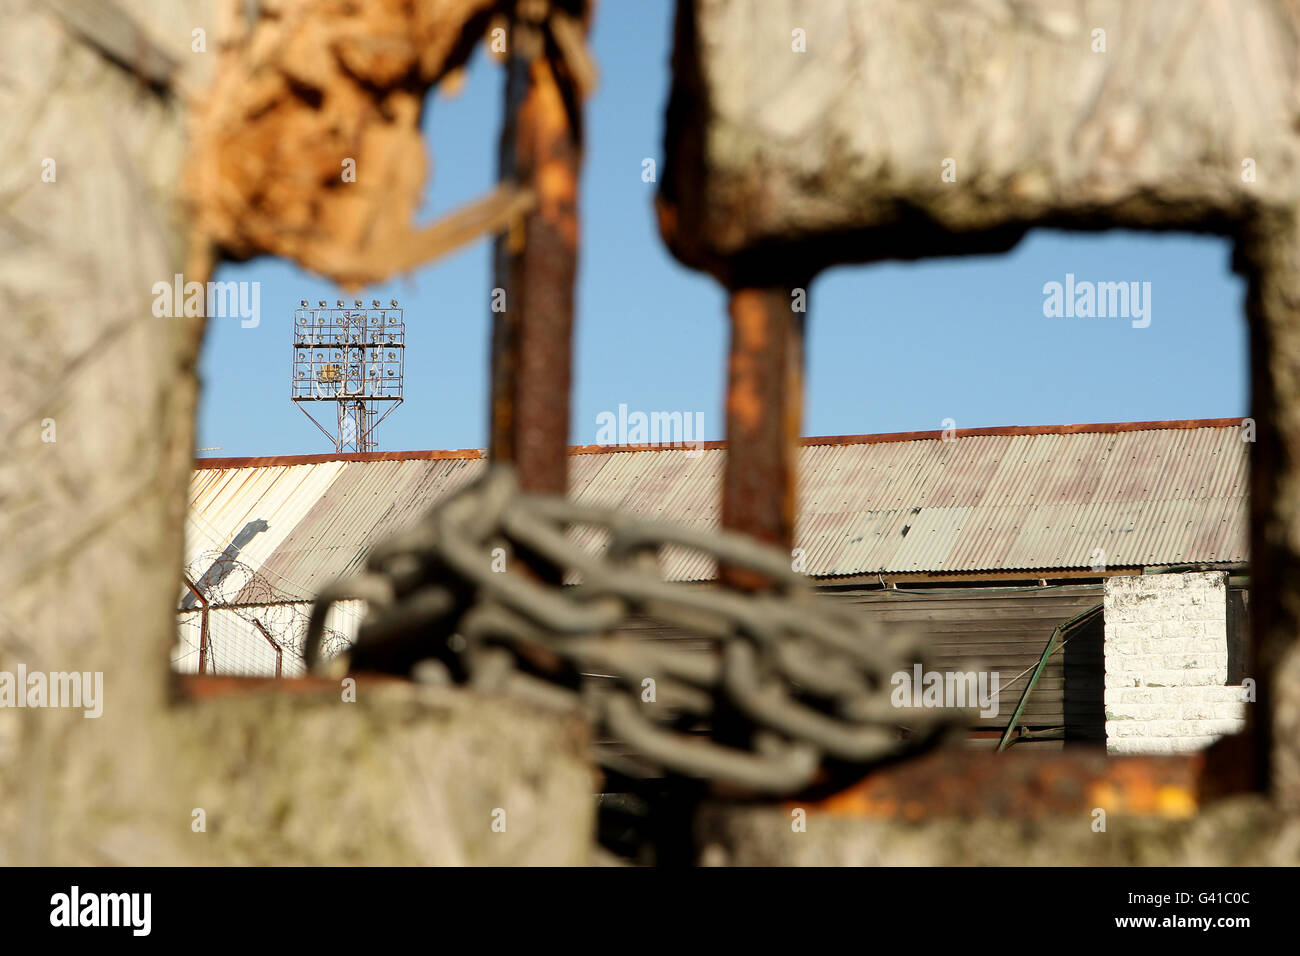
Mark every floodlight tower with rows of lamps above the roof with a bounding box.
[290,299,406,453]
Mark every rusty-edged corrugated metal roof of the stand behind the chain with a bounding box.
[187,419,1248,590]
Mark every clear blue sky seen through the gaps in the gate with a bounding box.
[198,0,1248,457]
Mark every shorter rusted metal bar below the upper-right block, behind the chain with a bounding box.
[719,287,803,591]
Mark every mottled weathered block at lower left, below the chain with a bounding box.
[169,682,598,866]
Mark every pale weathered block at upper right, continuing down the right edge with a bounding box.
[658,0,1300,810]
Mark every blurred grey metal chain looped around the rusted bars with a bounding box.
[304,466,954,796]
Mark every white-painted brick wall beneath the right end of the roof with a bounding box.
[1105,571,1245,753]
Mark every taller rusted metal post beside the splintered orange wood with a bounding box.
[490,1,582,494]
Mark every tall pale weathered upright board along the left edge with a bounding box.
[0,0,212,864]
